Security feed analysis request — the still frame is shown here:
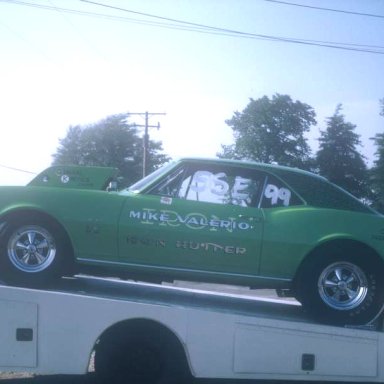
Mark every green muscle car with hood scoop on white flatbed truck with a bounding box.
[0,159,384,324]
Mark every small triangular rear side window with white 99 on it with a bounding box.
[261,175,303,208]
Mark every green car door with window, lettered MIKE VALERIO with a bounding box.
[119,163,265,276]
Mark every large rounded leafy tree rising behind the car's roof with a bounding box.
[218,94,316,168]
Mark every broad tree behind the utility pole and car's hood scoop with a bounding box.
[53,114,169,185]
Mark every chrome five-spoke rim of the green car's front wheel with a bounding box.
[7,225,56,273]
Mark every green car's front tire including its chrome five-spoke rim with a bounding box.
[0,218,66,286]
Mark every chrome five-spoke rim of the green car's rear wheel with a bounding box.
[318,262,368,310]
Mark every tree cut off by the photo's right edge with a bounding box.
[371,99,384,212]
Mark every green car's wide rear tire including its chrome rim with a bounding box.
[297,251,384,325]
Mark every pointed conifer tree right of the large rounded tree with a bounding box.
[316,104,370,198]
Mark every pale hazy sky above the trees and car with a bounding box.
[0,0,384,184]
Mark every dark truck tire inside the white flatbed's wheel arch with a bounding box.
[95,335,191,384]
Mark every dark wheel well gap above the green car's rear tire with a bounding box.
[293,239,384,291]
